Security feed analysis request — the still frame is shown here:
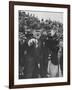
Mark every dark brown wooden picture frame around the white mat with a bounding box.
[9,1,70,89]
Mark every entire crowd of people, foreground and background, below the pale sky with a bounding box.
[19,11,63,79]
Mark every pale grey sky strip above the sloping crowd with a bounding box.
[26,11,63,23]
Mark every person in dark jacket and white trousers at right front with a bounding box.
[46,30,58,77]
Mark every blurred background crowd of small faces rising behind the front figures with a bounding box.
[19,11,63,40]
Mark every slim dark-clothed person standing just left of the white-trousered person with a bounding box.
[40,32,48,77]
